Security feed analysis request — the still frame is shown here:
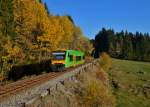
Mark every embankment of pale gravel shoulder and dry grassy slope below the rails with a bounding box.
[0,57,115,107]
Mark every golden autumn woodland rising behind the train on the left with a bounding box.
[0,0,92,74]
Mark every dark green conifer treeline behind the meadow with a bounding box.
[91,28,150,61]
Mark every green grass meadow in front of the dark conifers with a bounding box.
[109,59,150,107]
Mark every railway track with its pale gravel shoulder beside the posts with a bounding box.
[0,60,98,107]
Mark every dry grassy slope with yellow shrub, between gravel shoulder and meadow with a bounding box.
[41,60,116,107]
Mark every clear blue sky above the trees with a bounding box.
[43,0,150,38]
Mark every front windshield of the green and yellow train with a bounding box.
[52,52,66,60]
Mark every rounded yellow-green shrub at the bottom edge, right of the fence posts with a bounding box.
[77,77,115,107]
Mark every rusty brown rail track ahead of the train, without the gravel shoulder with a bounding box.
[0,70,69,101]
